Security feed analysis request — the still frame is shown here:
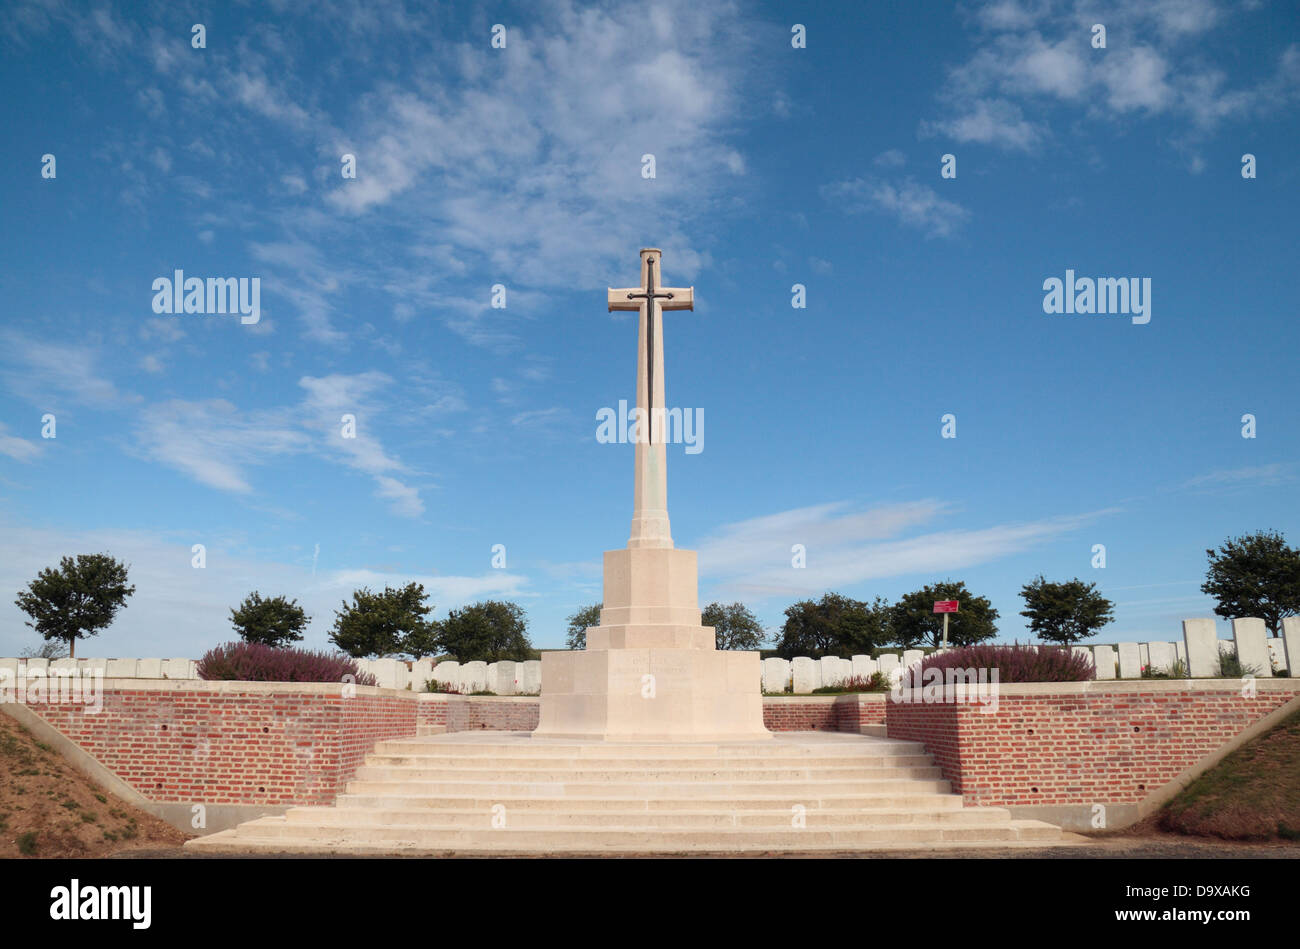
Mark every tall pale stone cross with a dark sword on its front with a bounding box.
[608,247,696,547]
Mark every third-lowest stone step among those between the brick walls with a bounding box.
[345,762,943,785]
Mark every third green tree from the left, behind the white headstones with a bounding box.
[329,584,437,659]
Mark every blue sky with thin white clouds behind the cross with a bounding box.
[0,0,1300,655]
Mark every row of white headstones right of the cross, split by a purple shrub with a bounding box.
[762,616,1300,694]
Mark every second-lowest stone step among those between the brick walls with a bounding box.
[347,775,952,801]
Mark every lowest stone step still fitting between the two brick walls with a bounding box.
[337,792,977,814]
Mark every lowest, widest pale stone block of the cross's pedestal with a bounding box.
[533,647,772,741]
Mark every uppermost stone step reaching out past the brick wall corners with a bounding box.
[285,805,1011,829]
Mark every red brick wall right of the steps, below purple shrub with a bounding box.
[885,684,1300,805]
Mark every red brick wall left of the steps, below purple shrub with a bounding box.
[29,686,416,805]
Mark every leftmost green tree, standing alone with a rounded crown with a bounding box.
[14,554,135,657]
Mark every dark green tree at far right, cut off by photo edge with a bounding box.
[1201,530,1300,636]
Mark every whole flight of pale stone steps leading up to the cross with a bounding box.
[186,732,1078,854]
